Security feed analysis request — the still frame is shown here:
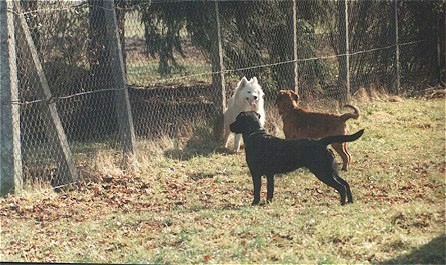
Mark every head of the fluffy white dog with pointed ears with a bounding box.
[235,77,265,110]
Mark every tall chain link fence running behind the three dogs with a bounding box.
[1,0,446,194]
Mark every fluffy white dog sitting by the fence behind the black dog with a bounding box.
[223,77,265,152]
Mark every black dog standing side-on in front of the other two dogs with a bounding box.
[230,111,364,205]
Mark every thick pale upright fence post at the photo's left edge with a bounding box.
[0,0,23,196]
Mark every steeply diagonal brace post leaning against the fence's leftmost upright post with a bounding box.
[14,1,78,183]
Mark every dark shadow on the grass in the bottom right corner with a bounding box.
[381,234,446,264]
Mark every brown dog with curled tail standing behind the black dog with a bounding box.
[276,90,359,171]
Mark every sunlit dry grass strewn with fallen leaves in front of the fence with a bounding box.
[0,96,446,264]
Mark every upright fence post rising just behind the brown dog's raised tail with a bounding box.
[338,0,350,102]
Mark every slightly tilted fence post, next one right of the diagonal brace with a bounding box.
[103,0,135,154]
